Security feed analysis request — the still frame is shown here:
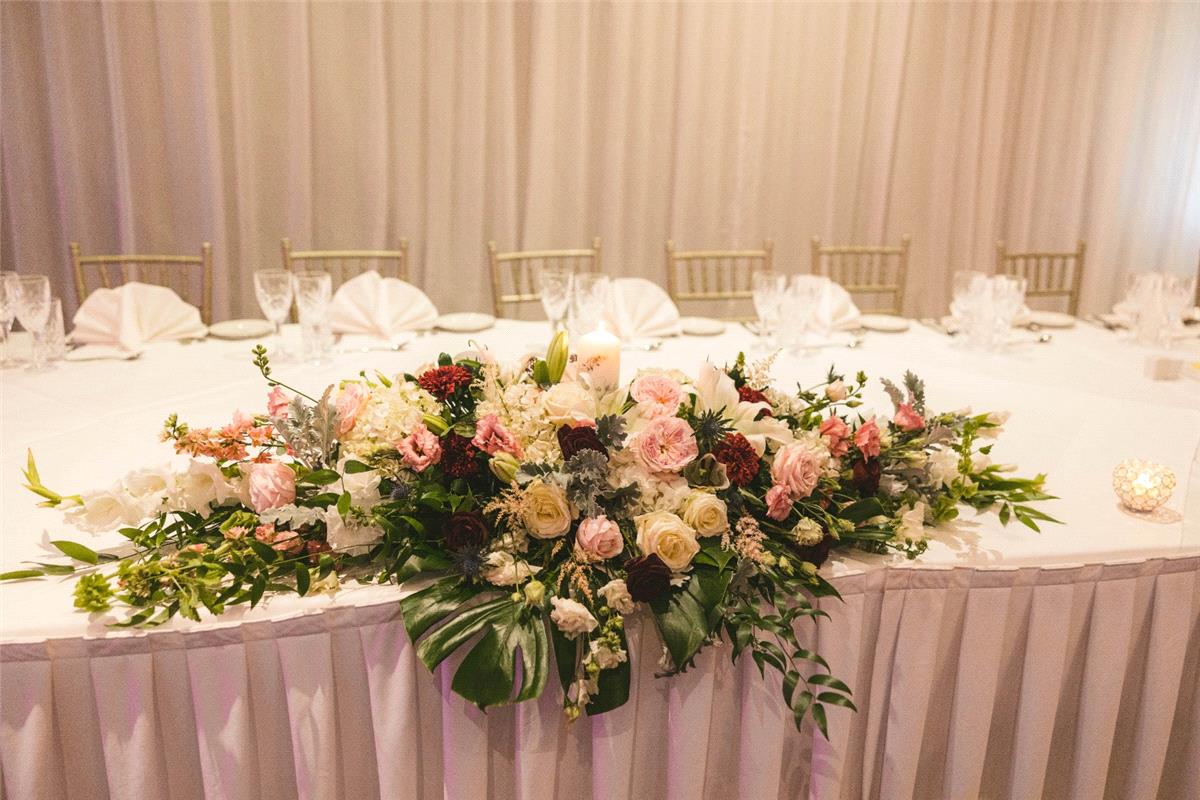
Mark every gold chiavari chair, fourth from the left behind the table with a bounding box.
[666,239,775,321]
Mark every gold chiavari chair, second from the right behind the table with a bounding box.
[812,234,912,314]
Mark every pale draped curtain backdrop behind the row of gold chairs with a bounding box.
[0,2,1200,318]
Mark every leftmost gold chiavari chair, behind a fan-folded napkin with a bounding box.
[71,242,212,325]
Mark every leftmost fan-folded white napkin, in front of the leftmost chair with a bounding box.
[71,282,208,350]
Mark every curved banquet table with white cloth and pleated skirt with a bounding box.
[0,323,1200,799]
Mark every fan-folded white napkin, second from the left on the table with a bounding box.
[329,270,438,339]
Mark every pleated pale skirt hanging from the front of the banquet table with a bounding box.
[0,555,1200,800]
